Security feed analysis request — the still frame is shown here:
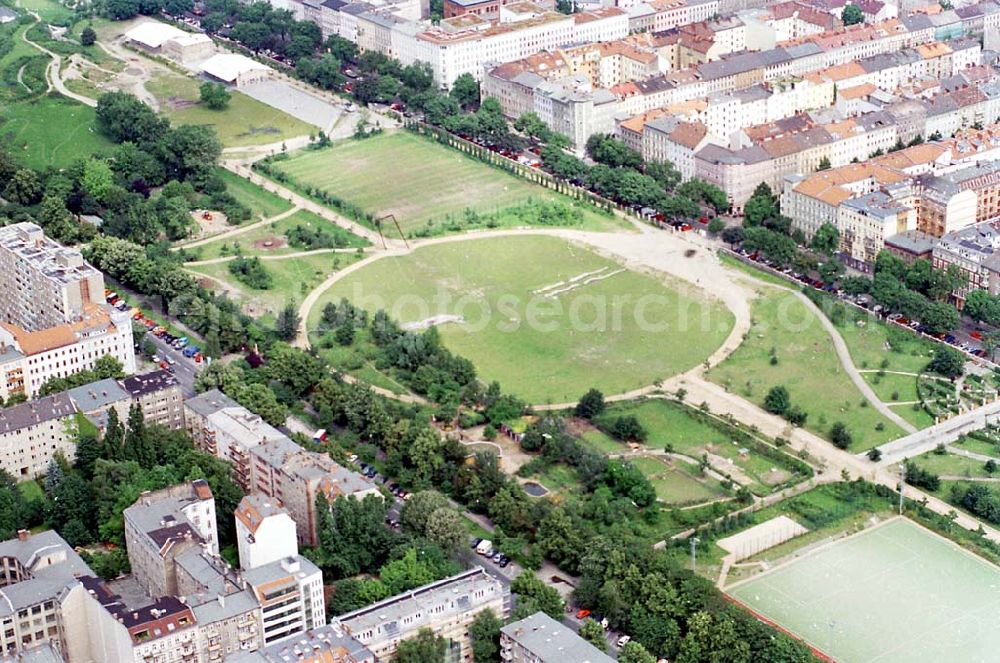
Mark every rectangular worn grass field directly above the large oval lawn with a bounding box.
[274,131,626,234]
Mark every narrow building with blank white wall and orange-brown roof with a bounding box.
[236,495,299,569]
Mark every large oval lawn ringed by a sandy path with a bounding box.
[309,237,733,403]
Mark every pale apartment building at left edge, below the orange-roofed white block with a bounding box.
[0,393,76,481]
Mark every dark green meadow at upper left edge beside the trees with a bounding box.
[0,95,113,169]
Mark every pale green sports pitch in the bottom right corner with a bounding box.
[727,518,1000,663]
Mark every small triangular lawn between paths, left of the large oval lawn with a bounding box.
[187,253,357,315]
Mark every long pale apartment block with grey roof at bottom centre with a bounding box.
[332,567,510,661]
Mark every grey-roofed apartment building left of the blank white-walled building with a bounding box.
[123,479,219,598]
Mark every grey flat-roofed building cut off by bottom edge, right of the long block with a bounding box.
[500,611,615,663]
